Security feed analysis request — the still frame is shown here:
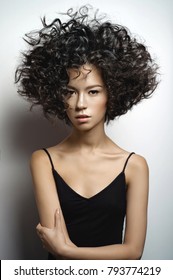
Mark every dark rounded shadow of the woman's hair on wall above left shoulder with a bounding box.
[6,105,70,155]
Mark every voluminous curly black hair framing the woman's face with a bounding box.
[15,6,158,123]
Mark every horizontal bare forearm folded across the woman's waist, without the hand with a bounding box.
[64,244,141,260]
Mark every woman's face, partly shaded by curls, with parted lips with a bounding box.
[65,64,107,130]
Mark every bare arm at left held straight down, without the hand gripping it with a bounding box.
[30,150,74,245]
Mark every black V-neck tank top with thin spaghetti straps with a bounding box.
[43,149,134,258]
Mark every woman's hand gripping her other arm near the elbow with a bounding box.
[36,209,75,256]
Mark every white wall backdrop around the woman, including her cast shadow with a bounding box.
[0,0,173,259]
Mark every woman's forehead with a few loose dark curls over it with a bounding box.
[67,64,103,85]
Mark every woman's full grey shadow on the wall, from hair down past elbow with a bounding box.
[5,105,70,259]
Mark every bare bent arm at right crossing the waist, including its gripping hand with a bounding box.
[39,155,148,260]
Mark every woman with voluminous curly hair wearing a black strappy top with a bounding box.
[16,7,157,259]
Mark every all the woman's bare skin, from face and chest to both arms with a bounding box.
[31,65,149,259]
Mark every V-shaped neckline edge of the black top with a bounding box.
[53,169,125,200]
